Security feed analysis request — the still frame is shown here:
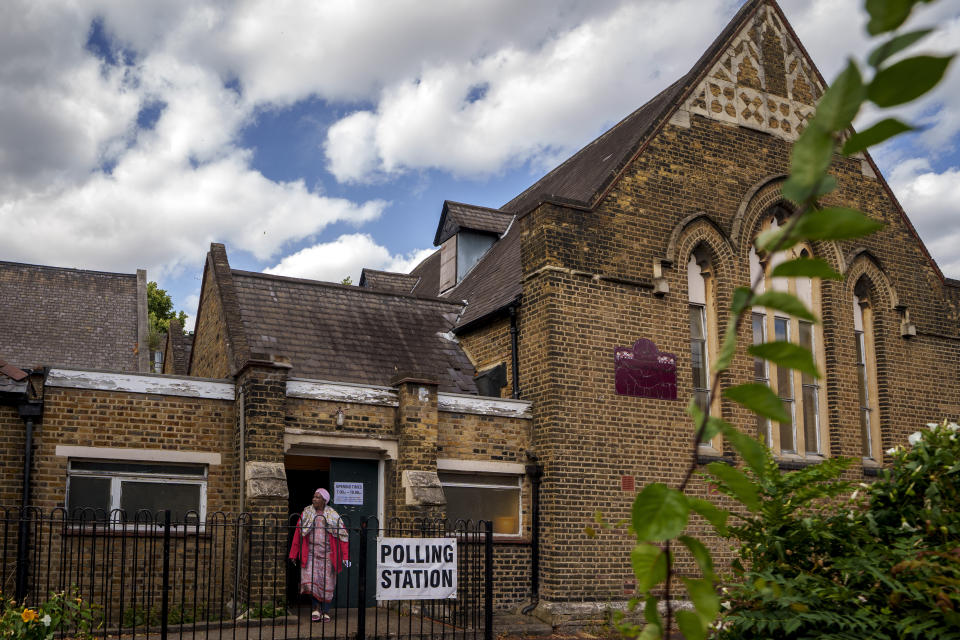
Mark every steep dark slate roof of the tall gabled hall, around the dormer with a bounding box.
[411,0,765,328]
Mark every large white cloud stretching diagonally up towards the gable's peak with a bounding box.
[325,0,730,181]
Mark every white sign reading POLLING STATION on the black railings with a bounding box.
[377,538,457,600]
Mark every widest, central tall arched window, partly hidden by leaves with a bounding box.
[750,207,826,457]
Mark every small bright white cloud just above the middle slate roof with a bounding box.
[264,233,434,283]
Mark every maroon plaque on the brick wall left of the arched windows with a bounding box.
[613,338,677,400]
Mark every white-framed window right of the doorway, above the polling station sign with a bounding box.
[439,471,522,535]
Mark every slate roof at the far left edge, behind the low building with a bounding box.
[0,262,140,372]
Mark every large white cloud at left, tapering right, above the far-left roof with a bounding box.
[0,151,386,277]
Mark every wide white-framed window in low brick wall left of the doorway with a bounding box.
[67,459,207,523]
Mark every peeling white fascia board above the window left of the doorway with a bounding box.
[46,369,236,400]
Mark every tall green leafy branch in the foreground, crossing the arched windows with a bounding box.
[624,0,952,640]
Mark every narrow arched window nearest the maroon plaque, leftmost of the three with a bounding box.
[687,248,716,445]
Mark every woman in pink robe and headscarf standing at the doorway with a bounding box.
[290,489,348,621]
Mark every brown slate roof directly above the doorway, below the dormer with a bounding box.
[231,270,477,394]
